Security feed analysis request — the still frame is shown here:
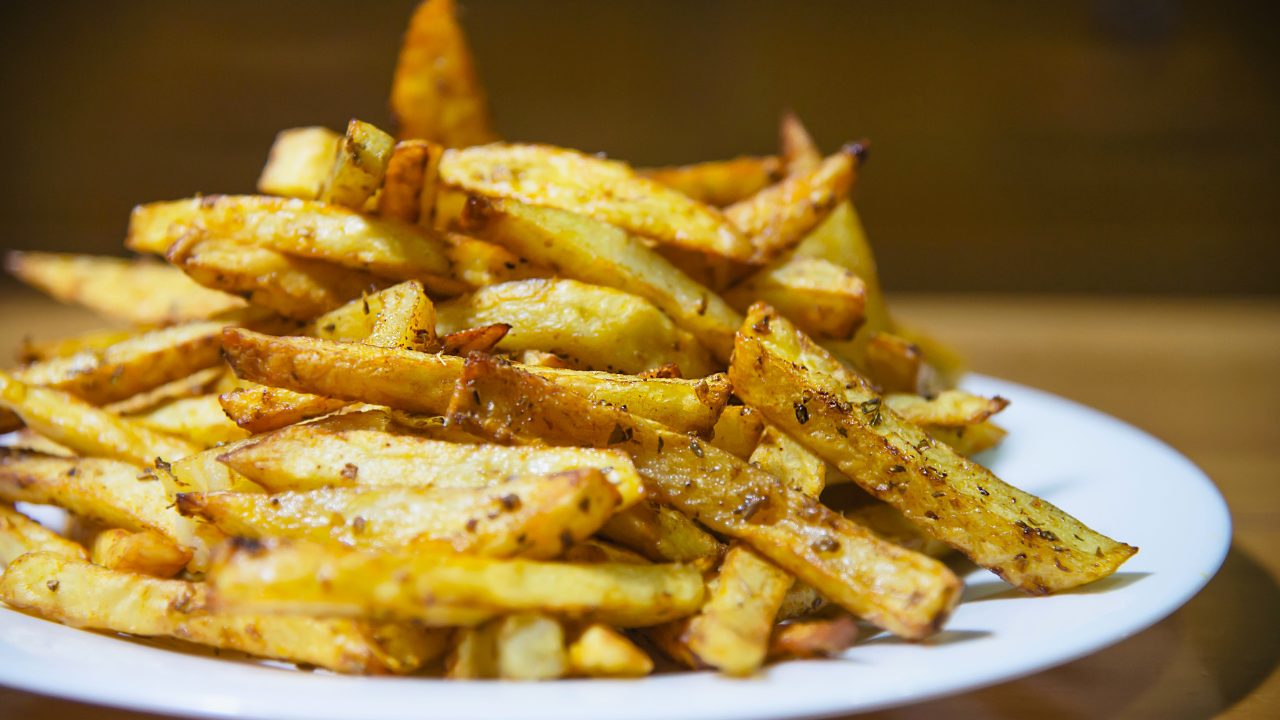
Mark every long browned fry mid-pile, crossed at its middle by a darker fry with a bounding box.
[223,329,730,433]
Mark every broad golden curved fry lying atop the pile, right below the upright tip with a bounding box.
[440,143,753,261]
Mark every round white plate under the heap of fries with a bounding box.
[0,375,1231,720]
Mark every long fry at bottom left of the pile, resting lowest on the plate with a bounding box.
[0,553,445,674]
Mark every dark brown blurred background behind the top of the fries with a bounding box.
[0,0,1280,293]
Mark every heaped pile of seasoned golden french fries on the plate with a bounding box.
[0,0,1137,679]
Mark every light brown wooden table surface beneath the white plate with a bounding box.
[0,288,1280,720]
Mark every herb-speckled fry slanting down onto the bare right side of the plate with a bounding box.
[727,304,1137,591]
